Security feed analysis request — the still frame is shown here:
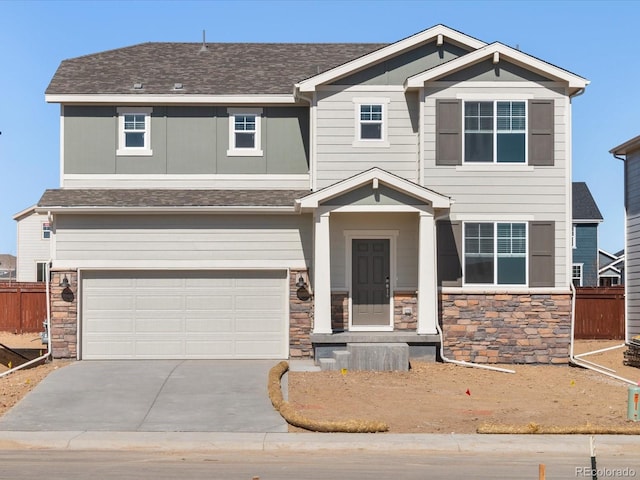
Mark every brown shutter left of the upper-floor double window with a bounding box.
[436,99,462,165]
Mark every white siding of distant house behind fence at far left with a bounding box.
[16,213,51,282]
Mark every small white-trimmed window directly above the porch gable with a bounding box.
[353,98,389,147]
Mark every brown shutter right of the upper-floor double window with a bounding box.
[529,100,555,166]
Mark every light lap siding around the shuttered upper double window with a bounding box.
[422,82,571,288]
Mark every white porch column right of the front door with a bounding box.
[417,212,438,335]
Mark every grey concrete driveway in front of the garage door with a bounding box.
[0,360,287,432]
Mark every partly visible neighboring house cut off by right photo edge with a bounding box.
[610,135,640,342]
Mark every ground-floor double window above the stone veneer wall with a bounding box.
[464,222,528,285]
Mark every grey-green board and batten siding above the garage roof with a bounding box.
[62,105,309,188]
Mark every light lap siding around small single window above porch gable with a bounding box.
[316,87,419,189]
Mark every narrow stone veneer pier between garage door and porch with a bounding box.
[289,270,313,358]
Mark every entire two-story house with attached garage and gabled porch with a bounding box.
[36,25,589,363]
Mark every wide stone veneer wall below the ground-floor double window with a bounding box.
[441,293,571,364]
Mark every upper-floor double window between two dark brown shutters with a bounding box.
[463,100,527,164]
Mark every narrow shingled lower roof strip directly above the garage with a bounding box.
[38,189,309,208]
